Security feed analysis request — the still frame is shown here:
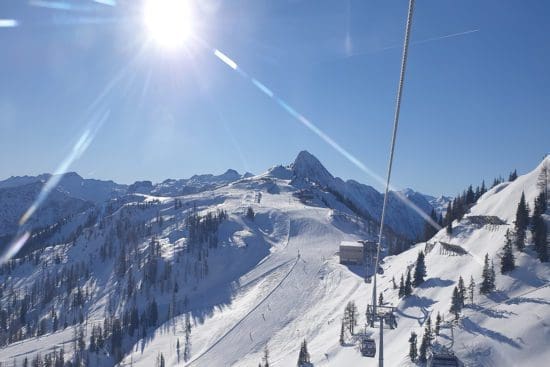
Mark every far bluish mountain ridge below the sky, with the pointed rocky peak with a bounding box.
[0,151,445,247]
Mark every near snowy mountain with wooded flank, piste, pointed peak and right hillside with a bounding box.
[0,152,550,367]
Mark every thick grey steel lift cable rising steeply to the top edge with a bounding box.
[372,0,415,314]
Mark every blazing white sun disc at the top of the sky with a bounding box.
[143,0,193,49]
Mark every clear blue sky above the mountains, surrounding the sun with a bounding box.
[0,0,550,195]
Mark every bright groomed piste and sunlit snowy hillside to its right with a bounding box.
[119,157,550,366]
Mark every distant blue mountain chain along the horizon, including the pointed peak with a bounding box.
[0,151,432,252]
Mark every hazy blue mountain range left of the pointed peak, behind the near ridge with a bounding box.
[0,170,252,249]
